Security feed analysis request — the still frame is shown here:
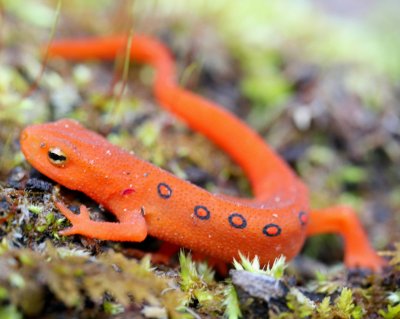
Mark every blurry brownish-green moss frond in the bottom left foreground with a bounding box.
[0,242,186,318]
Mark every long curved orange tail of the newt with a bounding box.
[49,35,296,199]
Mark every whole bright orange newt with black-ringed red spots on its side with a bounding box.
[21,36,383,270]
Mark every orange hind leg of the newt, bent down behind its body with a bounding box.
[307,206,385,271]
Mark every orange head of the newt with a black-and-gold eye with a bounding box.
[20,119,111,190]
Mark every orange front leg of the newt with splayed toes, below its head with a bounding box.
[56,202,147,242]
